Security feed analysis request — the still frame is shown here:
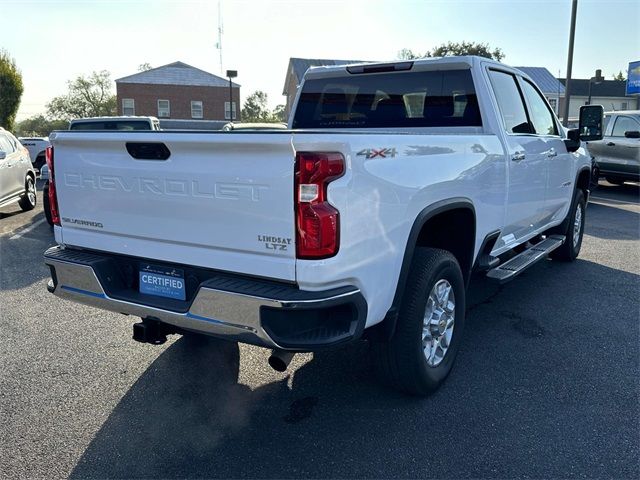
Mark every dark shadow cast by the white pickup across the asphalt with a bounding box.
[71,260,640,478]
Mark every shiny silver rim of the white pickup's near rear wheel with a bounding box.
[422,279,456,367]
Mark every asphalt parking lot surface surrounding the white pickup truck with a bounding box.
[0,179,640,478]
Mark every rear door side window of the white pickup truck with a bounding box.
[489,70,533,133]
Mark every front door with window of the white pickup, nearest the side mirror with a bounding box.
[520,78,575,224]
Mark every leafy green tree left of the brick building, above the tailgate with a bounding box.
[47,70,117,120]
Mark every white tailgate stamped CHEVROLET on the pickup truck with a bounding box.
[53,131,295,281]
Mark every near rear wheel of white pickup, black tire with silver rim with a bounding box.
[373,247,465,396]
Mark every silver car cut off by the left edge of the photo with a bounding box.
[0,127,36,211]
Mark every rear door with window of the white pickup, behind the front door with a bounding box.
[489,69,548,248]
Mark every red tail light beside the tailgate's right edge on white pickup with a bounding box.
[295,152,345,259]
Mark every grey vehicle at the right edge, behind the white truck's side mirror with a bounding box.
[587,110,640,184]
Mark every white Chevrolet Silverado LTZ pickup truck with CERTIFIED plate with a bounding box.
[45,57,602,395]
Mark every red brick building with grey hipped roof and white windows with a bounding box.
[116,62,240,121]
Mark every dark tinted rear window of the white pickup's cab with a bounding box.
[293,70,482,128]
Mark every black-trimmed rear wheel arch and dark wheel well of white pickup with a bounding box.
[368,197,476,339]
